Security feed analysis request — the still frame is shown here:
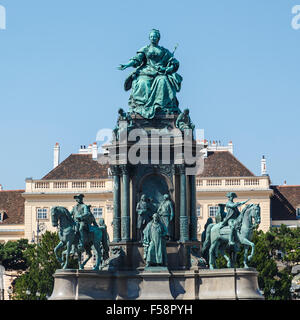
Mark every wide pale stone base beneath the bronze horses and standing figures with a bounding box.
[50,268,264,300]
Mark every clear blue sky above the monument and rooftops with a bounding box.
[0,0,300,189]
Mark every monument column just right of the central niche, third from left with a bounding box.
[179,165,189,242]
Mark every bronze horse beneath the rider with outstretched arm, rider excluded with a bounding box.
[202,204,260,269]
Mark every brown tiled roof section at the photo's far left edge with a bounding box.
[0,190,25,224]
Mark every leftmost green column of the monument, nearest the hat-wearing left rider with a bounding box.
[111,166,121,242]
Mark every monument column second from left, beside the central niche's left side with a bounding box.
[121,165,130,241]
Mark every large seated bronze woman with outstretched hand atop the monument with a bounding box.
[118,29,182,119]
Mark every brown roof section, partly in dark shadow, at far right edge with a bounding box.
[271,185,300,220]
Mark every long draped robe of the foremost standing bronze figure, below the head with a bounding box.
[143,221,168,265]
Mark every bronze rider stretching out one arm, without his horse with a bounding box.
[220,192,249,246]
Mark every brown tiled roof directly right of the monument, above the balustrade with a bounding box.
[198,151,254,177]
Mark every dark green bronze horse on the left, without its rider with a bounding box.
[51,206,109,270]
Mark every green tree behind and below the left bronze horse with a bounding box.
[14,231,76,300]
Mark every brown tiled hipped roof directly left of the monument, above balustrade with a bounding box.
[42,154,109,180]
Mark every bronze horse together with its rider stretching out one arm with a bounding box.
[202,192,260,269]
